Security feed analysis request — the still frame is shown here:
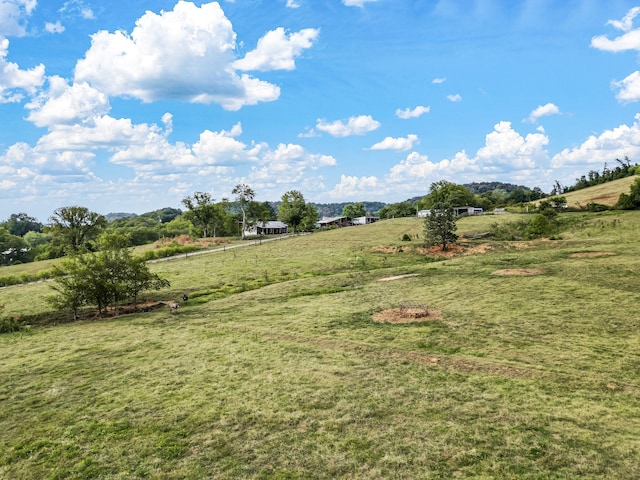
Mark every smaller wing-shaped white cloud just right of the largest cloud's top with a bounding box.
[233,27,320,72]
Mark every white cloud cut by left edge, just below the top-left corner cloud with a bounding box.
[0,38,44,103]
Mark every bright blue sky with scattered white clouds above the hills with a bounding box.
[0,0,640,221]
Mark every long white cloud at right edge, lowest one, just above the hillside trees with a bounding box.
[551,114,640,168]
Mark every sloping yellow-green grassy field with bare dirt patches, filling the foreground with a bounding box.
[0,212,640,479]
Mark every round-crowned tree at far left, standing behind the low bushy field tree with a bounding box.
[47,206,107,253]
